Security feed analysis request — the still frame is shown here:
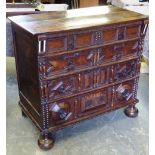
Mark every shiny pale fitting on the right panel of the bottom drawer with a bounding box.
[116,84,132,101]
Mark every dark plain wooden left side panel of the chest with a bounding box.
[13,25,41,128]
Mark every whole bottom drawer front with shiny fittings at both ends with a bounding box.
[49,80,134,126]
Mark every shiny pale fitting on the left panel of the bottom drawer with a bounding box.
[50,103,72,120]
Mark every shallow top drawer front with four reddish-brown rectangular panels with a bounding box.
[39,21,141,53]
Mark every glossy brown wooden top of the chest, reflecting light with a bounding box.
[9,6,148,35]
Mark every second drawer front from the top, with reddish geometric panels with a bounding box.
[42,40,140,77]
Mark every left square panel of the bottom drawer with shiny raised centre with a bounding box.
[49,98,76,126]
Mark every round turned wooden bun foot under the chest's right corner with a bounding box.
[124,105,138,117]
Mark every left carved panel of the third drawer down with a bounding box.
[48,75,78,100]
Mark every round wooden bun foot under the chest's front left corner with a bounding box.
[38,134,54,151]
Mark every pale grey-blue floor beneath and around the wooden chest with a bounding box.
[6,58,149,155]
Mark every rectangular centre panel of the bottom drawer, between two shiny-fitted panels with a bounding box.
[77,88,111,117]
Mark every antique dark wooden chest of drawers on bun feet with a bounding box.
[9,6,148,150]
